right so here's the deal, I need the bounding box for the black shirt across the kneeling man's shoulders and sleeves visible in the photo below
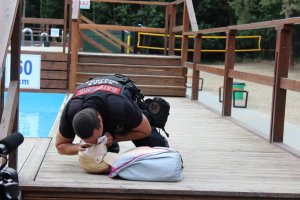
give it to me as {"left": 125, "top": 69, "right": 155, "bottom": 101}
{"left": 59, "top": 91, "right": 142, "bottom": 138}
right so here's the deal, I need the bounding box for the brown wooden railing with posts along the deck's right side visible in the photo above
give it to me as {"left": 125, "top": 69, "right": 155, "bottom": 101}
{"left": 182, "top": 4, "right": 300, "bottom": 142}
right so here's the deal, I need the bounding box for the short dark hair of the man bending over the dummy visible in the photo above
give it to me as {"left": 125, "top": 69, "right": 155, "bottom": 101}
{"left": 72, "top": 108, "right": 100, "bottom": 139}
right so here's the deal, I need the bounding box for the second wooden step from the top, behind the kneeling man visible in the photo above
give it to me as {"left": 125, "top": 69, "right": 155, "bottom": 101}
{"left": 77, "top": 63, "right": 183, "bottom": 76}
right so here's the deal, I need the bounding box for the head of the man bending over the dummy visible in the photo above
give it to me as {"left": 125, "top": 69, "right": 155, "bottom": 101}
{"left": 72, "top": 108, "right": 103, "bottom": 143}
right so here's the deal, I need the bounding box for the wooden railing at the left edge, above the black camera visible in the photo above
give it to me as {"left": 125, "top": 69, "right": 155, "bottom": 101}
{"left": 0, "top": 0, "right": 22, "bottom": 169}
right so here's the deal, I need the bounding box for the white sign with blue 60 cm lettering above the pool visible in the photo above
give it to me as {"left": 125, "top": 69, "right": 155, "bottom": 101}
{"left": 5, "top": 54, "right": 41, "bottom": 89}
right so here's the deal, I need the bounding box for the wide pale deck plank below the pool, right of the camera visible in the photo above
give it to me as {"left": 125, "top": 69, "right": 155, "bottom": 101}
{"left": 19, "top": 138, "right": 51, "bottom": 181}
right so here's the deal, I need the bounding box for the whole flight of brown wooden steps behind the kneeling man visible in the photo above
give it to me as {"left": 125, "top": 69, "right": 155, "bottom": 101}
{"left": 76, "top": 53, "right": 186, "bottom": 97}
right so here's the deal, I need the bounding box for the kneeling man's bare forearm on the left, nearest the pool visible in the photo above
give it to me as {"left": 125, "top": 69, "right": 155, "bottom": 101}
{"left": 55, "top": 132, "right": 84, "bottom": 155}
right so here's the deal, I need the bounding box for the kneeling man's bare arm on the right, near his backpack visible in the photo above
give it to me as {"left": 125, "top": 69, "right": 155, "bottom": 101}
{"left": 114, "top": 114, "right": 152, "bottom": 142}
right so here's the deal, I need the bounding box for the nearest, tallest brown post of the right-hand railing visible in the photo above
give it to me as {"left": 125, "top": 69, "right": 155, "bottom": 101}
{"left": 270, "top": 25, "right": 293, "bottom": 142}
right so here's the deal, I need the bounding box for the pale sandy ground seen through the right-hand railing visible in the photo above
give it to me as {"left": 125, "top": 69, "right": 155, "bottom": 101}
{"left": 188, "top": 61, "right": 300, "bottom": 126}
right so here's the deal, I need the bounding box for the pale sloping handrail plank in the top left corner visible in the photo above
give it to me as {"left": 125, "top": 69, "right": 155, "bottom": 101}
{"left": 0, "top": 0, "right": 19, "bottom": 71}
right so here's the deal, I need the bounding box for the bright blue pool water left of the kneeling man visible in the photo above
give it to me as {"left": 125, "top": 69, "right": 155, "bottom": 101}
{"left": 5, "top": 92, "right": 66, "bottom": 137}
